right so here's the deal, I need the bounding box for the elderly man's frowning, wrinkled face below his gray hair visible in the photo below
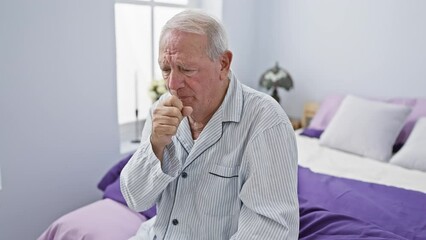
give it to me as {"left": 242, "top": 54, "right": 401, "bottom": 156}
{"left": 158, "top": 31, "right": 224, "bottom": 114}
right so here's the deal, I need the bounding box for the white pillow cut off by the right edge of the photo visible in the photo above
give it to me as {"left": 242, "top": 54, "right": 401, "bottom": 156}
{"left": 390, "top": 118, "right": 426, "bottom": 172}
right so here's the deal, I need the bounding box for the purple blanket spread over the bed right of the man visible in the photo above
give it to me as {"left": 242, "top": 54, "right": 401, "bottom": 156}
{"left": 298, "top": 167, "right": 426, "bottom": 239}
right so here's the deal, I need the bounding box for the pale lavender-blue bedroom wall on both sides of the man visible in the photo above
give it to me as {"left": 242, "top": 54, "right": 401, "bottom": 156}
{"left": 0, "top": 0, "right": 426, "bottom": 239}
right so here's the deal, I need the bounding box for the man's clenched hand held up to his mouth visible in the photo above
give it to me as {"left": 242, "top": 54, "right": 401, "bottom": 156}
{"left": 151, "top": 95, "right": 192, "bottom": 161}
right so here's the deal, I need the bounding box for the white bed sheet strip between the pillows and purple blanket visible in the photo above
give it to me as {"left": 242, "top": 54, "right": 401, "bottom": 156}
{"left": 296, "top": 130, "right": 426, "bottom": 193}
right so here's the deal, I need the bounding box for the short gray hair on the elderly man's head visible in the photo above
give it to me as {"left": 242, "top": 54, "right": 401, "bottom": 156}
{"left": 160, "top": 10, "right": 228, "bottom": 61}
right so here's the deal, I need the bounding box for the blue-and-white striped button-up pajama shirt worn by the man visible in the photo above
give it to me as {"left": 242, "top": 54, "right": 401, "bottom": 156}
{"left": 121, "top": 72, "right": 299, "bottom": 240}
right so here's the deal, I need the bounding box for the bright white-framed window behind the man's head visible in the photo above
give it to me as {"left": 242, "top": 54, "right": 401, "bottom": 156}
{"left": 115, "top": 0, "right": 196, "bottom": 153}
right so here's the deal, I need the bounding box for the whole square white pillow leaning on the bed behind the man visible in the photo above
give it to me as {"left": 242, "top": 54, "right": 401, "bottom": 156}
{"left": 319, "top": 95, "right": 411, "bottom": 162}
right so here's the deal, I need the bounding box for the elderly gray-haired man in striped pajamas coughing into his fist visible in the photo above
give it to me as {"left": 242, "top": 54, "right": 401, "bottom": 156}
{"left": 121, "top": 11, "right": 299, "bottom": 240}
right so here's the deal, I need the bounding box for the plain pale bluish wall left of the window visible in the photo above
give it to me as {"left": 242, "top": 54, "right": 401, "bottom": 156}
{"left": 0, "top": 0, "right": 120, "bottom": 240}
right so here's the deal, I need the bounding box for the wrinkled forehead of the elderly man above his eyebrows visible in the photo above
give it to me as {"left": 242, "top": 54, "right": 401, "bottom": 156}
{"left": 159, "top": 31, "right": 207, "bottom": 60}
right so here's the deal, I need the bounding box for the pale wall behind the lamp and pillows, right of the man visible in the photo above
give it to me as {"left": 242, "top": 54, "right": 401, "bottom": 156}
{"left": 223, "top": 0, "right": 426, "bottom": 116}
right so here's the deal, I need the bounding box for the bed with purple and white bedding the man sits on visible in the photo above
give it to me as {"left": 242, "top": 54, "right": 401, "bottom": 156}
{"left": 38, "top": 95, "right": 426, "bottom": 240}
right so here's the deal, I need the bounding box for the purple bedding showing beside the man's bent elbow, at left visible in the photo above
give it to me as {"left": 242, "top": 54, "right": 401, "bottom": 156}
{"left": 98, "top": 154, "right": 157, "bottom": 219}
